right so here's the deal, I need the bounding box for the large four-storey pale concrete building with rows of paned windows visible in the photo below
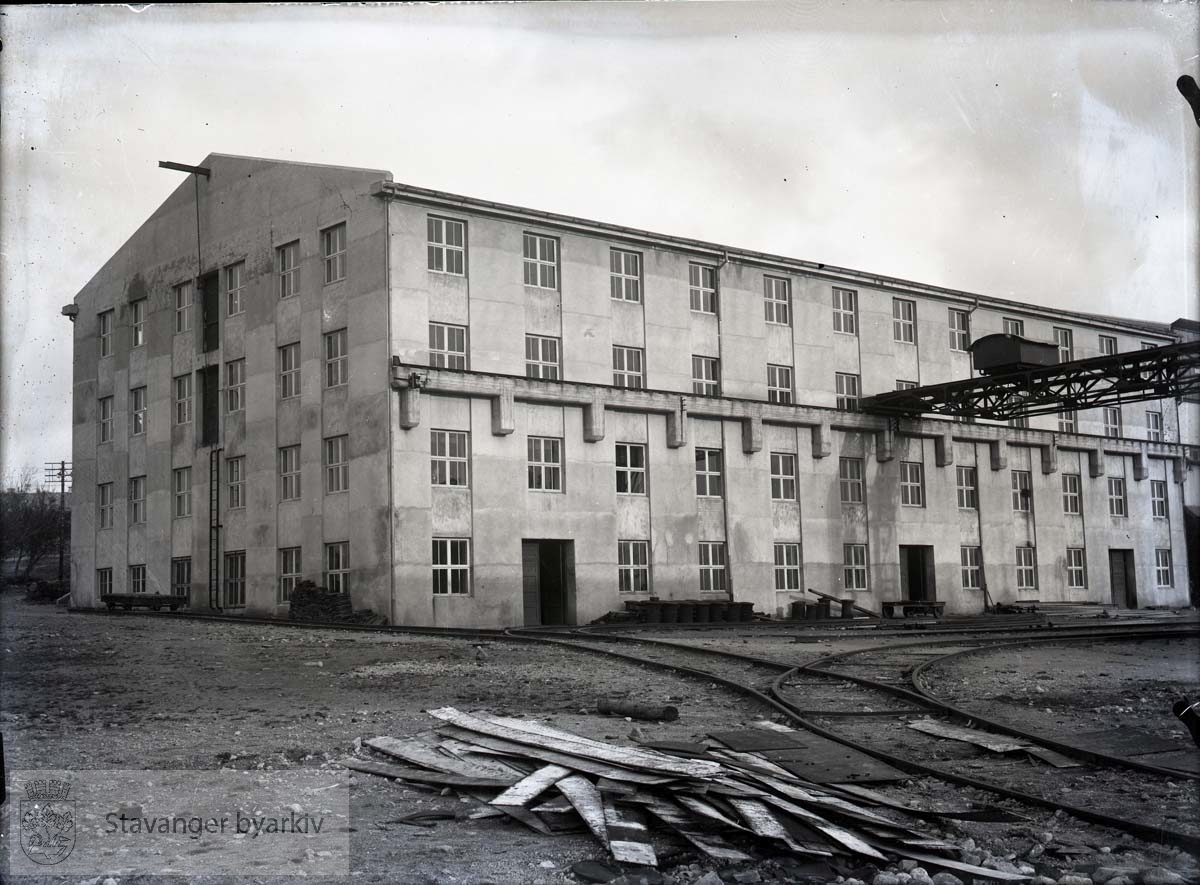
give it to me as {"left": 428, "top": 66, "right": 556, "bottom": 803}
{"left": 72, "top": 155, "right": 1188, "bottom": 626}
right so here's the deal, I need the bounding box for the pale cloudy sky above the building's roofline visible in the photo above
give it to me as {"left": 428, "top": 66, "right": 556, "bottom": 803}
{"left": 0, "top": 0, "right": 1200, "bottom": 477}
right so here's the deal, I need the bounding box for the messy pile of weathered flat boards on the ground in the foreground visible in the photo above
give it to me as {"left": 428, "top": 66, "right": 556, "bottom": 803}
{"left": 342, "top": 706, "right": 1026, "bottom": 881}
